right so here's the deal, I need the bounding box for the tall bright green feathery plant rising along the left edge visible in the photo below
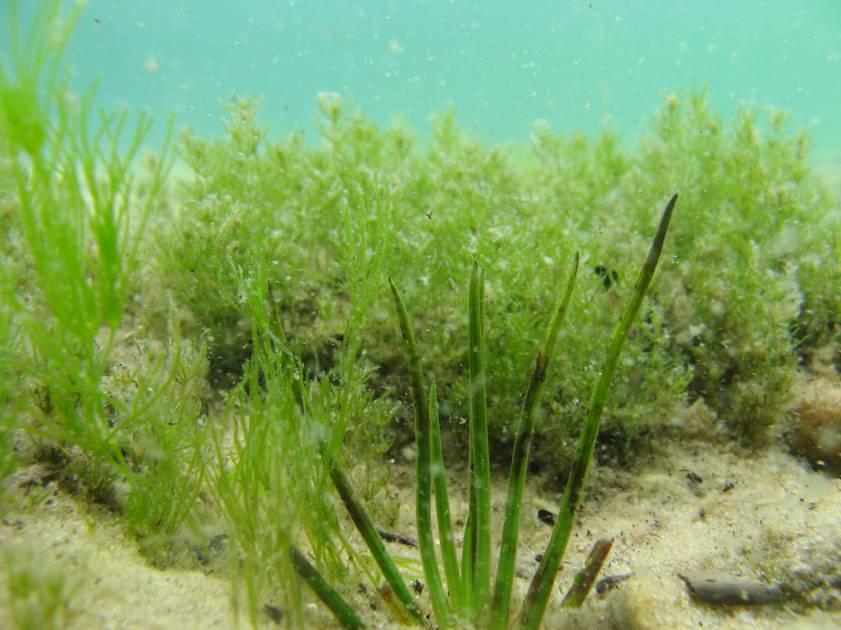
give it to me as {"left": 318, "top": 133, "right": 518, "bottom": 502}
{"left": 0, "top": 0, "right": 172, "bottom": 462}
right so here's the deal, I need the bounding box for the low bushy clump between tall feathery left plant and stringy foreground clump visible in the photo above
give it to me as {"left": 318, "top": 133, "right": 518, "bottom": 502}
{"left": 112, "top": 334, "right": 212, "bottom": 565}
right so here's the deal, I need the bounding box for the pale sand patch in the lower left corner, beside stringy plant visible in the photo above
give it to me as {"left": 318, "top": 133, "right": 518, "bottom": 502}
{"left": 0, "top": 492, "right": 235, "bottom": 629}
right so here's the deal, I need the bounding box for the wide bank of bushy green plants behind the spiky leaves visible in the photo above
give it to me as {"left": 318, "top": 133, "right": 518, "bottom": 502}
{"left": 161, "top": 84, "right": 841, "bottom": 474}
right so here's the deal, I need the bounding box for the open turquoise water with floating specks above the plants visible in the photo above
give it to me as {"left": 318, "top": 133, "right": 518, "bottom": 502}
{"left": 0, "top": 0, "right": 841, "bottom": 162}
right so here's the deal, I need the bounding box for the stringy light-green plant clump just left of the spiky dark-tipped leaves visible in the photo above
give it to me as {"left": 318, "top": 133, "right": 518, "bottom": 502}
{"left": 209, "top": 283, "right": 343, "bottom": 626}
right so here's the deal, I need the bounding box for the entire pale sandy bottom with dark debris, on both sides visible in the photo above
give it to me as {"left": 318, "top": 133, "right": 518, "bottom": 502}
{"left": 0, "top": 418, "right": 841, "bottom": 629}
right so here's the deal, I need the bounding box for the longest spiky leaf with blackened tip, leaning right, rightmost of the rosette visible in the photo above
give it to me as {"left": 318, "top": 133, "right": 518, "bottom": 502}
{"left": 520, "top": 194, "right": 677, "bottom": 630}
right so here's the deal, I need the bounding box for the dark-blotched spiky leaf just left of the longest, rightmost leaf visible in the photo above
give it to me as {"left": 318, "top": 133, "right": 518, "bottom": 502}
{"left": 490, "top": 252, "right": 579, "bottom": 630}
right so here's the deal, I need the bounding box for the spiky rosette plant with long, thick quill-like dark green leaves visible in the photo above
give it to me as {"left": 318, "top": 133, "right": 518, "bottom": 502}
{"left": 297, "top": 195, "right": 677, "bottom": 629}
